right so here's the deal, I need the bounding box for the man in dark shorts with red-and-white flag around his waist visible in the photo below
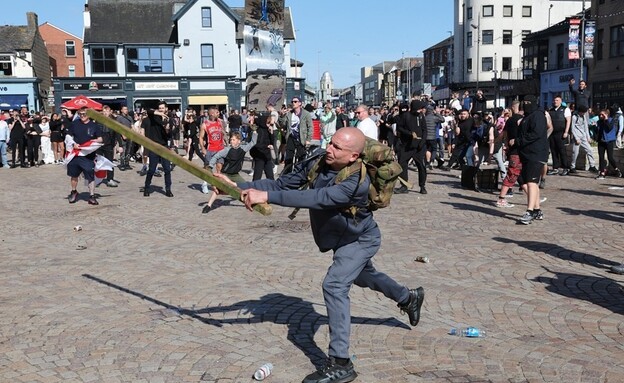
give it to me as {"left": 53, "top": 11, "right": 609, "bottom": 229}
{"left": 67, "top": 108, "right": 103, "bottom": 205}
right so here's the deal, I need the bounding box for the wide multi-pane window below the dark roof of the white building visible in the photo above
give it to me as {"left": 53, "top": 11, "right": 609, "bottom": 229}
{"left": 126, "top": 47, "right": 173, "bottom": 73}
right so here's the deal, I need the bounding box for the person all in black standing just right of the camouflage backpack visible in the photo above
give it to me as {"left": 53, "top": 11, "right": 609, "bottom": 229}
{"left": 394, "top": 100, "right": 427, "bottom": 194}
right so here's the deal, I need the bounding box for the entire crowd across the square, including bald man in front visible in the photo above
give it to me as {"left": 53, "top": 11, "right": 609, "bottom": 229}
{"left": 0, "top": 82, "right": 624, "bottom": 383}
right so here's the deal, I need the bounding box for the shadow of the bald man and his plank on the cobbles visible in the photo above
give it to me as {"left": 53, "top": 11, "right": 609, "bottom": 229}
{"left": 82, "top": 274, "right": 411, "bottom": 368}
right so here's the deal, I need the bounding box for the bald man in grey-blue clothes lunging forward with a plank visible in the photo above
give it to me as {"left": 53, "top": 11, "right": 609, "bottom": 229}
{"left": 216, "top": 127, "right": 424, "bottom": 383}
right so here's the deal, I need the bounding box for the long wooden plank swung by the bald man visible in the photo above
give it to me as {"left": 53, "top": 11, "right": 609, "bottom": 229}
{"left": 87, "top": 109, "right": 273, "bottom": 215}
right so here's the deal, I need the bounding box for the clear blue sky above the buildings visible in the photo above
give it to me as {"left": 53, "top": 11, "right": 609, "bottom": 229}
{"left": 0, "top": 0, "right": 454, "bottom": 88}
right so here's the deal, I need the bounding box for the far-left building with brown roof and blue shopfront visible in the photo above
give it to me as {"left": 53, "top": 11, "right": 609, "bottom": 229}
{"left": 0, "top": 12, "right": 51, "bottom": 111}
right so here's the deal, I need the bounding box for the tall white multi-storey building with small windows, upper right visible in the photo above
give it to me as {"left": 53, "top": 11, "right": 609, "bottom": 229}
{"left": 453, "top": 0, "right": 584, "bottom": 88}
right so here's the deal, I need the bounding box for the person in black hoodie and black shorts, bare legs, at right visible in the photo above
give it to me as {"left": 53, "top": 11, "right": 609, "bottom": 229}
{"left": 509, "top": 95, "right": 549, "bottom": 225}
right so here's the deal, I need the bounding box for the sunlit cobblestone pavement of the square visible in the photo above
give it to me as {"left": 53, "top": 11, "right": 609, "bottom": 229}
{"left": 0, "top": 158, "right": 624, "bottom": 383}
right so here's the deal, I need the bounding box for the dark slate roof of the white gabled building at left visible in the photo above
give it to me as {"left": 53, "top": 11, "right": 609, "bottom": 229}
{"left": 84, "top": 0, "right": 180, "bottom": 44}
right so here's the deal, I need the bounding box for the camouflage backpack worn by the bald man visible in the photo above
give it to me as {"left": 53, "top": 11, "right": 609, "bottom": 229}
{"left": 308, "top": 137, "right": 402, "bottom": 216}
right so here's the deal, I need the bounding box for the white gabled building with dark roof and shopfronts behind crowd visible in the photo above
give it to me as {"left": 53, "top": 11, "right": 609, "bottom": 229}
{"left": 54, "top": 0, "right": 305, "bottom": 110}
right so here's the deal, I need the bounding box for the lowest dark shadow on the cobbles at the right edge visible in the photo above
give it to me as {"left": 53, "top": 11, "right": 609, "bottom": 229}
{"left": 532, "top": 268, "right": 624, "bottom": 315}
